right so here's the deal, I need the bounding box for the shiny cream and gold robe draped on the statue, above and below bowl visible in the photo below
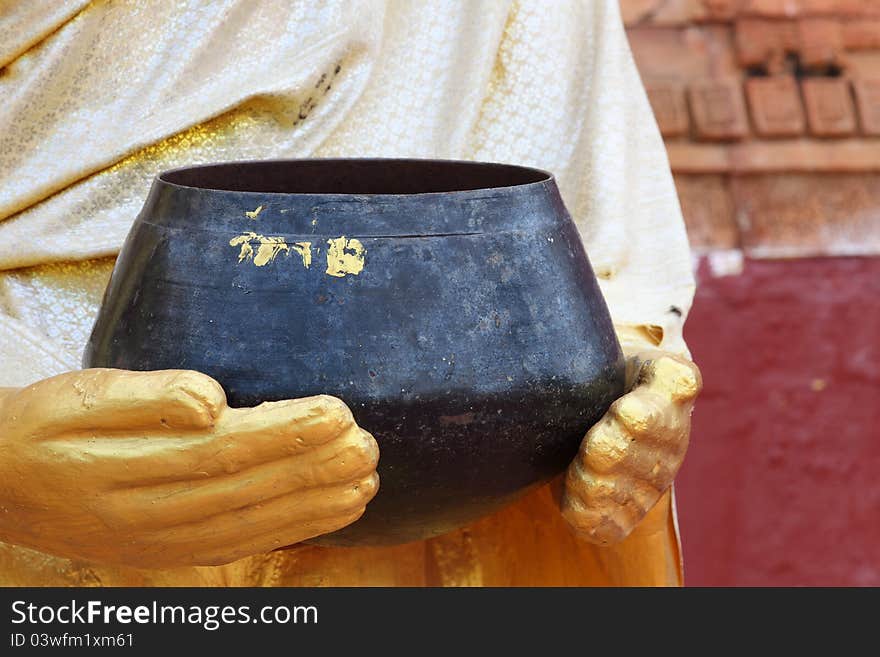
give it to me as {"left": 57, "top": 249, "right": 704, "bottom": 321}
{"left": 0, "top": 0, "right": 694, "bottom": 585}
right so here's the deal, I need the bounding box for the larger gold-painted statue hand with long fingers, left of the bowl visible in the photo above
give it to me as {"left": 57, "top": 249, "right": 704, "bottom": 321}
{"left": 0, "top": 369, "right": 379, "bottom": 568}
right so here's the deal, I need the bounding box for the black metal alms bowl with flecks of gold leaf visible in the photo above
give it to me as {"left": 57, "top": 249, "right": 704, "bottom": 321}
{"left": 84, "top": 160, "right": 623, "bottom": 545}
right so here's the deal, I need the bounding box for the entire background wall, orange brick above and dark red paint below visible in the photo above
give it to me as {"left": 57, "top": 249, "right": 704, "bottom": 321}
{"left": 621, "top": 0, "right": 880, "bottom": 585}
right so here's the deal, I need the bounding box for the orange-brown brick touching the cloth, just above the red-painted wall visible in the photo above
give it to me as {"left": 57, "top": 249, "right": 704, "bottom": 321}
{"left": 675, "top": 174, "right": 739, "bottom": 250}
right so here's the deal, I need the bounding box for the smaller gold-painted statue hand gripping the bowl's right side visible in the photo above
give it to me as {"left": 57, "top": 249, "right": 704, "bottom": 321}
{"left": 562, "top": 351, "right": 702, "bottom": 545}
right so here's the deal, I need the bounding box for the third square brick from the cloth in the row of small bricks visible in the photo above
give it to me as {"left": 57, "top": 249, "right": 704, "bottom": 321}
{"left": 746, "top": 75, "right": 806, "bottom": 137}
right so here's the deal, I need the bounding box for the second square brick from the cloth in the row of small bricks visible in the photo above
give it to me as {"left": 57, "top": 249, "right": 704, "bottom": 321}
{"left": 688, "top": 78, "right": 749, "bottom": 141}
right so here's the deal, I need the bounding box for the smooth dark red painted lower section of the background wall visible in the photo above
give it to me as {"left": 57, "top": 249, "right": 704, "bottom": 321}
{"left": 677, "top": 258, "right": 880, "bottom": 586}
